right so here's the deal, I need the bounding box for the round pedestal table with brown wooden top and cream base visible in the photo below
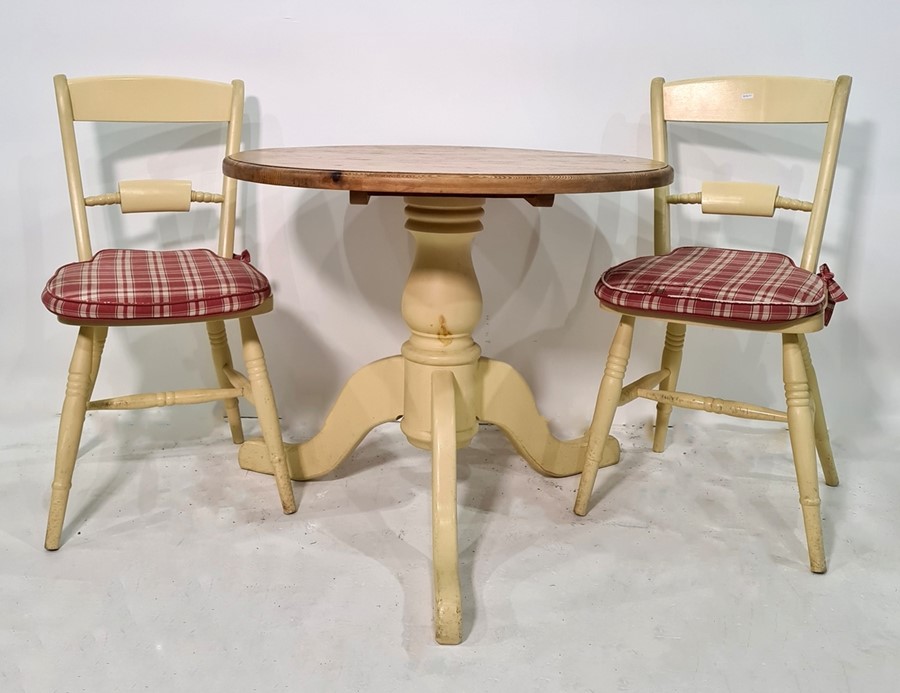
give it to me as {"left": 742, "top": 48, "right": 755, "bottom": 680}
{"left": 223, "top": 145, "right": 673, "bottom": 644}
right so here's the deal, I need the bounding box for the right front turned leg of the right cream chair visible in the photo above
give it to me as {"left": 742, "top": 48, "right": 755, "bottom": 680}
{"left": 782, "top": 334, "right": 826, "bottom": 573}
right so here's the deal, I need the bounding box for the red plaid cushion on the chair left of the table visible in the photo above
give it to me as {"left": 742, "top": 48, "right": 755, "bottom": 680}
{"left": 41, "top": 249, "right": 272, "bottom": 321}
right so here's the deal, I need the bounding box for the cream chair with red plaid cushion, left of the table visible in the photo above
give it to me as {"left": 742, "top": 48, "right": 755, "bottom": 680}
{"left": 42, "top": 75, "right": 296, "bottom": 550}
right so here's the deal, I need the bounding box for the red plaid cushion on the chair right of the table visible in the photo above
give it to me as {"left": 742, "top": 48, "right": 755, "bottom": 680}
{"left": 595, "top": 247, "right": 847, "bottom": 324}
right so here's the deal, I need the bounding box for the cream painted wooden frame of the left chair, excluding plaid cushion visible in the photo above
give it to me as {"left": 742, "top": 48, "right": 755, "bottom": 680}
{"left": 45, "top": 75, "right": 296, "bottom": 550}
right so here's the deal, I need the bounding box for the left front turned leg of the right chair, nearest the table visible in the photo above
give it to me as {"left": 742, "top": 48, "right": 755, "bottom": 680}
{"left": 575, "top": 315, "right": 634, "bottom": 515}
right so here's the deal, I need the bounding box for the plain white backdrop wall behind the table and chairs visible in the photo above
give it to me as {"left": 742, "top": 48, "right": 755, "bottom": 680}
{"left": 0, "top": 0, "right": 900, "bottom": 444}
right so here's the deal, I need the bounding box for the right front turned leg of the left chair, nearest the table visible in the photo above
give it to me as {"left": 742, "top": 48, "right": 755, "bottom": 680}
{"left": 240, "top": 318, "right": 297, "bottom": 515}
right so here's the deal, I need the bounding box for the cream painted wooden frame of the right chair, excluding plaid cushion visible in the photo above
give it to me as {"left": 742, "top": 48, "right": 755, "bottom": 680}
{"left": 575, "top": 76, "right": 850, "bottom": 572}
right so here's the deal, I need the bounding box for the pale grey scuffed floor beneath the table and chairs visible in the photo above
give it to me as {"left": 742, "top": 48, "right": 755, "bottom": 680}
{"left": 0, "top": 407, "right": 900, "bottom": 693}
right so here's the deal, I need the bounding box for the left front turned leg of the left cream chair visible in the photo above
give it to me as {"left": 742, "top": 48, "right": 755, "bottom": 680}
{"left": 44, "top": 327, "right": 94, "bottom": 551}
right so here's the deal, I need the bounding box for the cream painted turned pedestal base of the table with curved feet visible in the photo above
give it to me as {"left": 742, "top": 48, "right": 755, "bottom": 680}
{"left": 240, "top": 197, "right": 619, "bottom": 644}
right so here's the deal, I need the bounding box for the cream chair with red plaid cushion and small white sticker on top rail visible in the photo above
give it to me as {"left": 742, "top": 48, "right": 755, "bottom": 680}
{"left": 575, "top": 76, "right": 850, "bottom": 573}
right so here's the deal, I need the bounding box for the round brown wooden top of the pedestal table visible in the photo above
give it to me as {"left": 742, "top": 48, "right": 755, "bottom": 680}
{"left": 222, "top": 145, "right": 673, "bottom": 197}
